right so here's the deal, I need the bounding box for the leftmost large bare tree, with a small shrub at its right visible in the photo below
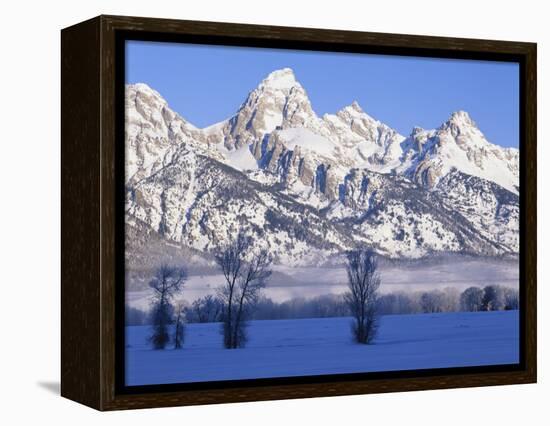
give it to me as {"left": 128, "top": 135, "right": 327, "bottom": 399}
{"left": 149, "top": 264, "right": 187, "bottom": 349}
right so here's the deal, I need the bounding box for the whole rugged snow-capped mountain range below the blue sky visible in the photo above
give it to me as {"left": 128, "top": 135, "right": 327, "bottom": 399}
{"left": 126, "top": 68, "right": 519, "bottom": 264}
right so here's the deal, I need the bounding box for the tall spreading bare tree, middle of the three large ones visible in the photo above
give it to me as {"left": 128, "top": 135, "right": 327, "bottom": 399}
{"left": 215, "top": 232, "right": 271, "bottom": 349}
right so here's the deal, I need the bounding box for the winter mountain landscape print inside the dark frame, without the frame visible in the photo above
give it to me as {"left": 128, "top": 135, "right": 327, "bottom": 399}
{"left": 124, "top": 41, "right": 521, "bottom": 386}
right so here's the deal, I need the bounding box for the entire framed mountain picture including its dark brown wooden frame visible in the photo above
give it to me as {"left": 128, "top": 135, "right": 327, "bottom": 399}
{"left": 61, "top": 16, "right": 536, "bottom": 410}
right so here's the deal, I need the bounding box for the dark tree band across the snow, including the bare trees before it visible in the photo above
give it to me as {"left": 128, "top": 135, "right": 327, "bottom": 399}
{"left": 126, "top": 232, "right": 519, "bottom": 349}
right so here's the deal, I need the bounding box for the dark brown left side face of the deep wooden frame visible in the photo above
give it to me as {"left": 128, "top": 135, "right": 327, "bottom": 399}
{"left": 61, "top": 18, "right": 101, "bottom": 409}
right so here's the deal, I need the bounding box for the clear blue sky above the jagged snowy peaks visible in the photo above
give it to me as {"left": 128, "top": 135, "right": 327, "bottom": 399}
{"left": 126, "top": 41, "right": 519, "bottom": 147}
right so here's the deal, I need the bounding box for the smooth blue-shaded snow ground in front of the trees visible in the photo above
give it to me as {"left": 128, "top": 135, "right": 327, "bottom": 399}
{"left": 126, "top": 311, "right": 519, "bottom": 386}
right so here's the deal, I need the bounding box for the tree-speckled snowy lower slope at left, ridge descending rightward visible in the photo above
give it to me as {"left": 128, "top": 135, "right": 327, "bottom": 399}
{"left": 126, "top": 145, "right": 353, "bottom": 265}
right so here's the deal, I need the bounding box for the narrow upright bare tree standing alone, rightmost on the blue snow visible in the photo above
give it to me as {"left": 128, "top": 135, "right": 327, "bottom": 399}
{"left": 345, "top": 249, "right": 380, "bottom": 344}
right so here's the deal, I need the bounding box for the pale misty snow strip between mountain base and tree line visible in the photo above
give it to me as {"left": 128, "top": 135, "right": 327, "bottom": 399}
{"left": 126, "top": 258, "right": 519, "bottom": 310}
